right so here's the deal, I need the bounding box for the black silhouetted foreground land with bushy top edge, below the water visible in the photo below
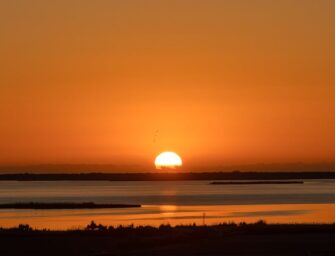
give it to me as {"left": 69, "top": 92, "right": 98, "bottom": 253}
{"left": 0, "top": 222, "right": 335, "bottom": 256}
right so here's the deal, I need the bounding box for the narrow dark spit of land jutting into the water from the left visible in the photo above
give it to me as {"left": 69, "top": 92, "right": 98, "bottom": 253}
{"left": 0, "top": 202, "right": 141, "bottom": 210}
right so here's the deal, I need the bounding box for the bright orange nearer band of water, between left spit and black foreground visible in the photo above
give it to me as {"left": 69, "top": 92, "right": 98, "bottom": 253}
{"left": 0, "top": 204, "right": 335, "bottom": 230}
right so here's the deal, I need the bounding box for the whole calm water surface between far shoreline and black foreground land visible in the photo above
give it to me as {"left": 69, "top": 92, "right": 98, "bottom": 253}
{"left": 0, "top": 180, "right": 335, "bottom": 229}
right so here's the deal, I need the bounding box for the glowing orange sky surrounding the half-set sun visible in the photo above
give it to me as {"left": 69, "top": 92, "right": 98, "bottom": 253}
{"left": 0, "top": 0, "right": 335, "bottom": 169}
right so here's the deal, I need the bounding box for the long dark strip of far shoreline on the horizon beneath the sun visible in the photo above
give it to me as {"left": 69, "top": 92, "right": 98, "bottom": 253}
{"left": 0, "top": 171, "right": 335, "bottom": 181}
